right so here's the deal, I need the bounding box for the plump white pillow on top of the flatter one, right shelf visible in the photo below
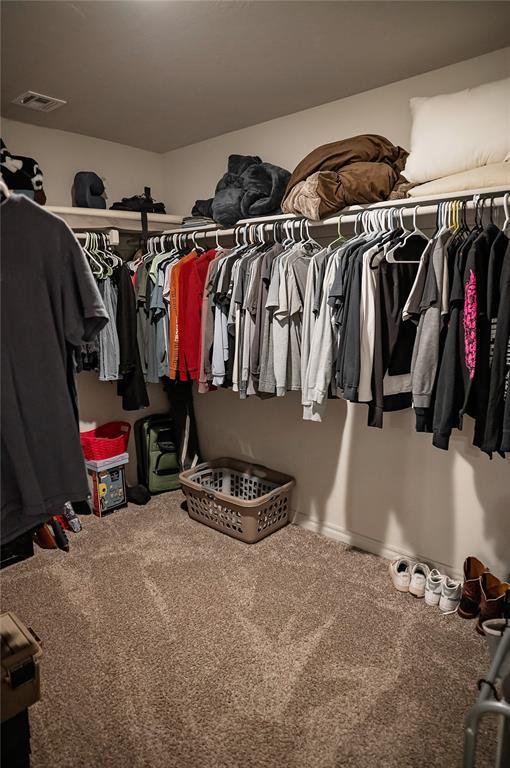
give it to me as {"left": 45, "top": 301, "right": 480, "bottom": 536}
{"left": 403, "top": 78, "right": 510, "bottom": 183}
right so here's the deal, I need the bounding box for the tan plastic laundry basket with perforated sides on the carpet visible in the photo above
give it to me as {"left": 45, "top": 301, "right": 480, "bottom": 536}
{"left": 180, "top": 459, "right": 295, "bottom": 544}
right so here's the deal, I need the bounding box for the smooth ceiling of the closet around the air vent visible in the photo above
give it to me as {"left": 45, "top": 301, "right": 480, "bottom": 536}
{"left": 1, "top": 0, "right": 510, "bottom": 152}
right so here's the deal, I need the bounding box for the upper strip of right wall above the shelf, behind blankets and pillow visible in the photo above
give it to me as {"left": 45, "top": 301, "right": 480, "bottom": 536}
{"left": 164, "top": 41, "right": 510, "bottom": 213}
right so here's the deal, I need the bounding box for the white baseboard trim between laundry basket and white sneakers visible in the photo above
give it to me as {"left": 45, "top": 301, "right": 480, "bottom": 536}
{"left": 293, "top": 512, "right": 464, "bottom": 580}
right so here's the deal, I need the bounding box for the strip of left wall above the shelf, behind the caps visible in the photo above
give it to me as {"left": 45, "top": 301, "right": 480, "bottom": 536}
{"left": 2, "top": 119, "right": 165, "bottom": 207}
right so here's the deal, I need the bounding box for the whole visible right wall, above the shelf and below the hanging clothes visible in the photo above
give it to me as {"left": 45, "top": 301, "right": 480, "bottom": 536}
{"left": 164, "top": 48, "right": 510, "bottom": 576}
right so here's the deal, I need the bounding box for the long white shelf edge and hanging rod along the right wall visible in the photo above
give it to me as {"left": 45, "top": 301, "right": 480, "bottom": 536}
{"left": 163, "top": 187, "right": 510, "bottom": 237}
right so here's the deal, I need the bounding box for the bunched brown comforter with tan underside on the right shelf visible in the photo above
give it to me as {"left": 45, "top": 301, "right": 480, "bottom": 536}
{"left": 282, "top": 134, "right": 409, "bottom": 220}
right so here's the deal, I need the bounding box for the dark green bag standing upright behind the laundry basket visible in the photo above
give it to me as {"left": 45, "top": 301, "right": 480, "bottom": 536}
{"left": 135, "top": 414, "right": 181, "bottom": 494}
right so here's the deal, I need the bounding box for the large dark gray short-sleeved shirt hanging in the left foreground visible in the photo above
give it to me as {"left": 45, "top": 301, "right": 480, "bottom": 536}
{"left": 1, "top": 195, "right": 108, "bottom": 543}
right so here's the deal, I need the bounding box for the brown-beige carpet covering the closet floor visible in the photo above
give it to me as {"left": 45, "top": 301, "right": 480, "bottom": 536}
{"left": 2, "top": 494, "right": 491, "bottom": 768}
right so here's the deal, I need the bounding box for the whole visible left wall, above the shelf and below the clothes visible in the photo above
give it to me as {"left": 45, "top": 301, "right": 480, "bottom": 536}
{"left": 2, "top": 120, "right": 168, "bottom": 482}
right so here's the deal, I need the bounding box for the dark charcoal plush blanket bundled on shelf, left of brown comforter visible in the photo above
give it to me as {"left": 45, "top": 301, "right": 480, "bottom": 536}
{"left": 191, "top": 155, "right": 290, "bottom": 227}
